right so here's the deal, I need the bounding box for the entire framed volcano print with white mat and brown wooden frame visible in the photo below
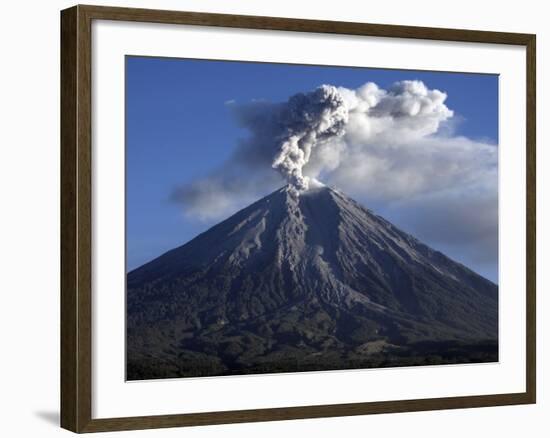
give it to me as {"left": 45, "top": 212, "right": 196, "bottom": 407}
{"left": 61, "top": 6, "right": 536, "bottom": 432}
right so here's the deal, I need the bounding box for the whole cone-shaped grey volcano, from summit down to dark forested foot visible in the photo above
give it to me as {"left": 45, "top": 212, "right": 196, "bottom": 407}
{"left": 127, "top": 186, "right": 498, "bottom": 380}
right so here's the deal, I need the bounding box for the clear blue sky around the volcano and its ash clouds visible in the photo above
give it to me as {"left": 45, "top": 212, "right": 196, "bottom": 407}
{"left": 126, "top": 57, "right": 498, "bottom": 281}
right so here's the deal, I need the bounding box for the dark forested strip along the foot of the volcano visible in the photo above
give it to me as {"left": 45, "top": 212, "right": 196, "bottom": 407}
{"left": 126, "top": 341, "right": 499, "bottom": 380}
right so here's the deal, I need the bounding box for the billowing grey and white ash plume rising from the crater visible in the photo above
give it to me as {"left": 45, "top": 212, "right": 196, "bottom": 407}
{"left": 260, "top": 81, "right": 453, "bottom": 194}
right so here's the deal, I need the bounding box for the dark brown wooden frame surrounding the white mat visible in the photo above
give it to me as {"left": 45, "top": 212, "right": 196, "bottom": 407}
{"left": 61, "top": 5, "right": 536, "bottom": 433}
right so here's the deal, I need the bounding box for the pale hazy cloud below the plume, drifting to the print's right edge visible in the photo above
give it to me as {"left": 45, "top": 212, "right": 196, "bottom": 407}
{"left": 314, "top": 137, "right": 498, "bottom": 202}
